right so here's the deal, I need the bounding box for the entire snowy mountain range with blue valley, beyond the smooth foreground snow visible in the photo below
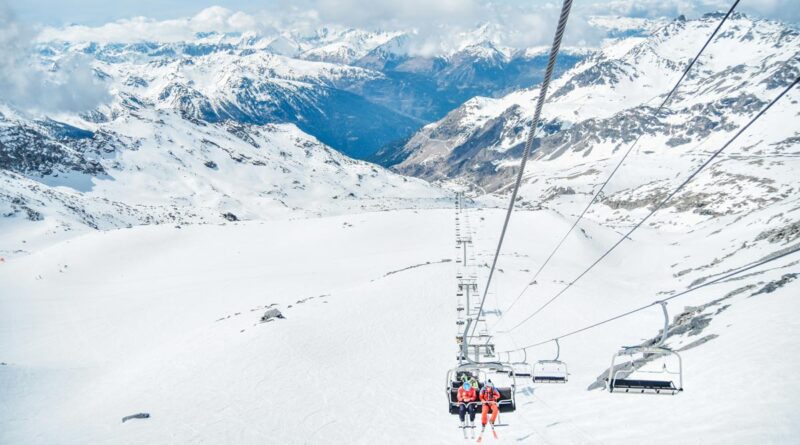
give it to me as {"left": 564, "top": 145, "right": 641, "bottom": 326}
{"left": 0, "top": 14, "right": 800, "bottom": 250}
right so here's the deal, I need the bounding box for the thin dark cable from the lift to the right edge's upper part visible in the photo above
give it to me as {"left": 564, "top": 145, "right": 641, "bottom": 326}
{"left": 502, "top": 76, "right": 800, "bottom": 332}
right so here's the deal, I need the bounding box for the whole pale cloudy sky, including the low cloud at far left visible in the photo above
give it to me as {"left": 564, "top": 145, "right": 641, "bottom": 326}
{"left": 0, "top": 0, "right": 800, "bottom": 110}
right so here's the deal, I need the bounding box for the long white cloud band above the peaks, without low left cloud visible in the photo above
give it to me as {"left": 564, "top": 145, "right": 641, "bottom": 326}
{"left": 28, "top": 0, "right": 800, "bottom": 54}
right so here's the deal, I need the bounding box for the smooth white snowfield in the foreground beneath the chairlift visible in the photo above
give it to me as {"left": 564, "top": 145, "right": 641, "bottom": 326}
{"left": 0, "top": 199, "right": 800, "bottom": 444}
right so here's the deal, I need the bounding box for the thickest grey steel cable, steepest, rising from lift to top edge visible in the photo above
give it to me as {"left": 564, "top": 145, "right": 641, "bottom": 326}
{"left": 472, "top": 0, "right": 572, "bottom": 334}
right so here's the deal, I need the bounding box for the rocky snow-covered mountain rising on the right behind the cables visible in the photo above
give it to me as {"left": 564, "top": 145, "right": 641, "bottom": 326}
{"left": 396, "top": 14, "right": 800, "bottom": 191}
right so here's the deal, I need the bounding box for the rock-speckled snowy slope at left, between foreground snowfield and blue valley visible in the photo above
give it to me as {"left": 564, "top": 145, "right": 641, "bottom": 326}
{"left": 0, "top": 98, "right": 446, "bottom": 255}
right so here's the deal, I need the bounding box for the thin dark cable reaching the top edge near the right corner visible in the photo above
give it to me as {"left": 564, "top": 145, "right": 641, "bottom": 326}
{"left": 492, "top": 0, "right": 741, "bottom": 326}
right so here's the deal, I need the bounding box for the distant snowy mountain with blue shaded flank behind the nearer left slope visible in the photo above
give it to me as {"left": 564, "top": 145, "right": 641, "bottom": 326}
{"left": 42, "top": 37, "right": 421, "bottom": 158}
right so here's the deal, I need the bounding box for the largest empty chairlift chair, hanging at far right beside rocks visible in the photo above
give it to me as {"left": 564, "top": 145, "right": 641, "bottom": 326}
{"left": 606, "top": 301, "right": 683, "bottom": 395}
